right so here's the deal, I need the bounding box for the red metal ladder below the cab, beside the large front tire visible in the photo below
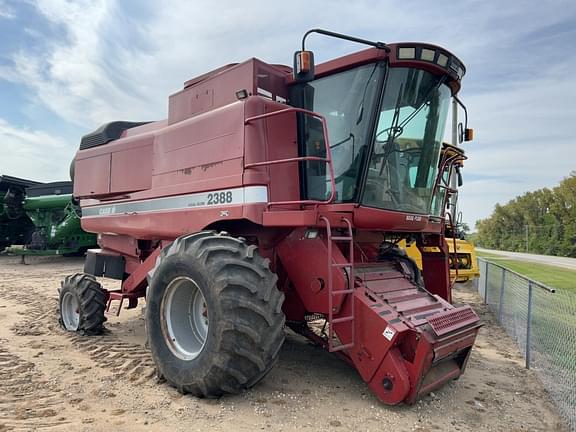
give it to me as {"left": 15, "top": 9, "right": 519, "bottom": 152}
{"left": 320, "top": 216, "right": 355, "bottom": 352}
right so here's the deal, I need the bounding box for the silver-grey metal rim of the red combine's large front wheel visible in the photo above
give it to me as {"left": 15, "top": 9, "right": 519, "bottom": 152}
{"left": 161, "top": 276, "right": 209, "bottom": 360}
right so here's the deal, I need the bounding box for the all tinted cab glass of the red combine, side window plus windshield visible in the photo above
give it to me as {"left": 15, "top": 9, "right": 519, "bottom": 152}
{"left": 293, "top": 63, "right": 451, "bottom": 214}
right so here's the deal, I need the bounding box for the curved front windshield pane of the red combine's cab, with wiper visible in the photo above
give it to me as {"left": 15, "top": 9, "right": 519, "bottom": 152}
{"left": 362, "top": 68, "right": 451, "bottom": 214}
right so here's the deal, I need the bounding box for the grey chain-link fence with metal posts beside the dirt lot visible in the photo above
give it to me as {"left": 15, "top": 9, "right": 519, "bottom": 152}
{"left": 478, "top": 258, "right": 576, "bottom": 431}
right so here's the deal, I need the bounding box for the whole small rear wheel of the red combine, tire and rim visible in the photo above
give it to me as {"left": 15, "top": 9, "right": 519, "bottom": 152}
{"left": 58, "top": 273, "right": 108, "bottom": 335}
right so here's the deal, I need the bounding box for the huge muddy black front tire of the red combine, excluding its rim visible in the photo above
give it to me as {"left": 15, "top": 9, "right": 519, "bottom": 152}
{"left": 146, "top": 231, "right": 285, "bottom": 398}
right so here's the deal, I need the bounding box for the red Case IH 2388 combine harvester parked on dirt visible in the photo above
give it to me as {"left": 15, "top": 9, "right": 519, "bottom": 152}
{"left": 60, "top": 29, "right": 480, "bottom": 405}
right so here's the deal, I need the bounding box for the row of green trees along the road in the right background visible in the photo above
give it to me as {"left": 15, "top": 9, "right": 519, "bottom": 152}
{"left": 475, "top": 171, "right": 576, "bottom": 257}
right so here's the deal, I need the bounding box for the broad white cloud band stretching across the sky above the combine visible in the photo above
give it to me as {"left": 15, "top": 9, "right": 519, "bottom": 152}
{"left": 15, "top": 0, "right": 568, "bottom": 126}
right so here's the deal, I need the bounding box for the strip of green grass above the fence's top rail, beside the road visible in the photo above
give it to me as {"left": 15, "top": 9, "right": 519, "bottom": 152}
{"left": 478, "top": 253, "right": 576, "bottom": 291}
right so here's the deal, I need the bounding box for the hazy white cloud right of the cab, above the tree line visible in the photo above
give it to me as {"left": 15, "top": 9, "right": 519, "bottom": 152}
{"left": 461, "top": 63, "right": 576, "bottom": 226}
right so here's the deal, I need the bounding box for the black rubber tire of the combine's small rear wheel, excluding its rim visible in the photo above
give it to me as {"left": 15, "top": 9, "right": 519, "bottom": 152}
{"left": 58, "top": 273, "right": 108, "bottom": 336}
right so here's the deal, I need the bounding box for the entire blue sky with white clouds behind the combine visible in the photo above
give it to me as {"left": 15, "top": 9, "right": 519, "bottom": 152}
{"left": 0, "top": 0, "right": 576, "bottom": 227}
